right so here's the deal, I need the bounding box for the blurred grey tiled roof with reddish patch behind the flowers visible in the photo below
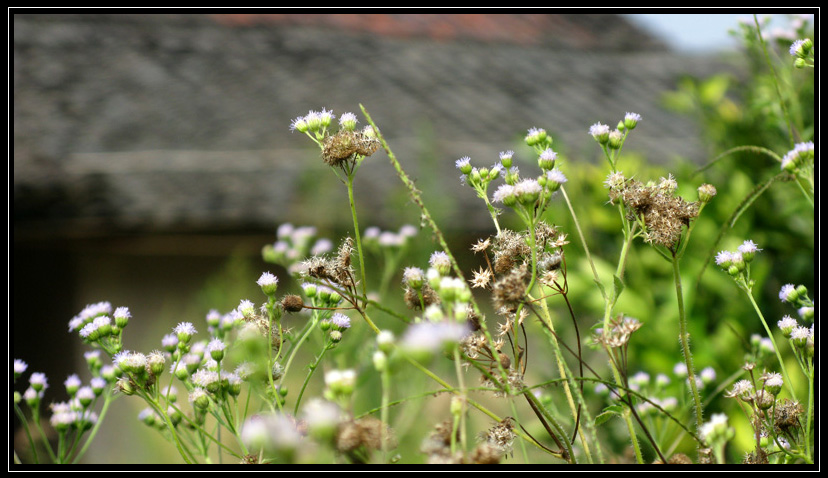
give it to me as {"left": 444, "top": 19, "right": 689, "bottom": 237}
{"left": 13, "top": 13, "right": 736, "bottom": 235}
